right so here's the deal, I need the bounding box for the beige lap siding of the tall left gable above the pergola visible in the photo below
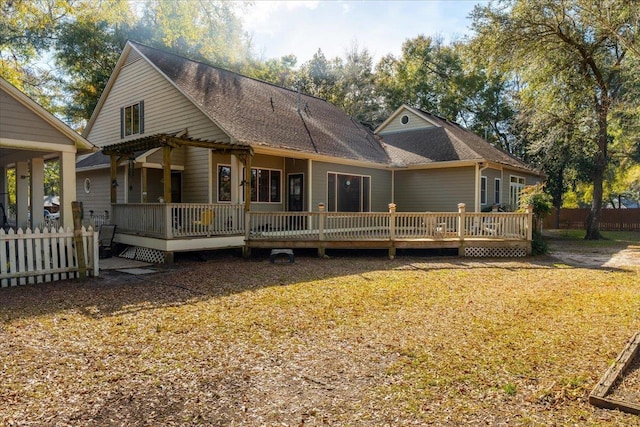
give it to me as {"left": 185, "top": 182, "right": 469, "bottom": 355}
{"left": 88, "top": 53, "right": 229, "bottom": 146}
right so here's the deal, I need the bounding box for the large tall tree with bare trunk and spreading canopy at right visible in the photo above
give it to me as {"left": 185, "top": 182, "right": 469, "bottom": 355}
{"left": 472, "top": 0, "right": 640, "bottom": 239}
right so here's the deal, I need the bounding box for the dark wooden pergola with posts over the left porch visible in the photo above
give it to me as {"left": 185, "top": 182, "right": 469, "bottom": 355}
{"left": 102, "top": 130, "right": 253, "bottom": 211}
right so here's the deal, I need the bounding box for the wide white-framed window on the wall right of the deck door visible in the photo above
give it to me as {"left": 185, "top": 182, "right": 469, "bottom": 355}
{"left": 327, "top": 172, "right": 371, "bottom": 212}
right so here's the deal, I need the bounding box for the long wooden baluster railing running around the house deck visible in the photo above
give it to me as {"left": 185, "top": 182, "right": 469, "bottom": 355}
{"left": 111, "top": 203, "right": 532, "bottom": 241}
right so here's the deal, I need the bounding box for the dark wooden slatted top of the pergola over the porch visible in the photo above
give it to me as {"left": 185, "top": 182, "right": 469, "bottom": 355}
{"left": 102, "top": 132, "right": 253, "bottom": 156}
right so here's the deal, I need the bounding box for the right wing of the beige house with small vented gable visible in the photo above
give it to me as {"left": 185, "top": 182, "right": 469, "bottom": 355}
{"left": 375, "top": 105, "right": 542, "bottom": 212}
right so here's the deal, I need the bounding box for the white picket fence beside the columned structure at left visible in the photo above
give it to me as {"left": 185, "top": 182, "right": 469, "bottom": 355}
{"left": 0, "top": 227, "right": 99, "bottom": 288}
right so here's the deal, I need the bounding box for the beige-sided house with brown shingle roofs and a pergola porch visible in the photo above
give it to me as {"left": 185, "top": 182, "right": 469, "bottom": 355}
{"left": 76, "top": 42, "right": 540, "bottom": 260}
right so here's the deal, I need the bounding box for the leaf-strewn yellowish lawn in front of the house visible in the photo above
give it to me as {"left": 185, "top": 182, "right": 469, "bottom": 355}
{"left": 0, "top": 233, "right": 640, "bottom": 426}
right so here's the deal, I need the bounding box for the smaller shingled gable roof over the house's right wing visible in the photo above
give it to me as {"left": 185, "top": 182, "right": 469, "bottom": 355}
{"left": 376, "top": 105, "right": 534, "bottom": 172}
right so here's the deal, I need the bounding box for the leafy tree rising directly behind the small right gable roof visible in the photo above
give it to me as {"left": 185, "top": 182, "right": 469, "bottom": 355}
{"left": 376, "top": 36, "right": 523, "bottom": 152}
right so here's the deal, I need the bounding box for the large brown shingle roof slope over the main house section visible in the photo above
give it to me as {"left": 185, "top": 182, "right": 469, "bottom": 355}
{"left": 129, "top": 42, "right": 389, "bottom": 164}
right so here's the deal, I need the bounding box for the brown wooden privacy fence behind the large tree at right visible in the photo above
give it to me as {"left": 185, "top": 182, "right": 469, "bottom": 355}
{"left": 543, "top": 208, "right": 640, "bottom": 231}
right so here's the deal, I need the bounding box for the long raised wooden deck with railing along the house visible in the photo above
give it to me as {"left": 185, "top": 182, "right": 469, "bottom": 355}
{"left": 112, "top": 203, "right": 532, "bottom": 257}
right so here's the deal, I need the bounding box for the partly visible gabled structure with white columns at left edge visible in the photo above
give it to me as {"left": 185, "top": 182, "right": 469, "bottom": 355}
{"left": 0, "top": 78, "right": 96, "bottom": 228}
